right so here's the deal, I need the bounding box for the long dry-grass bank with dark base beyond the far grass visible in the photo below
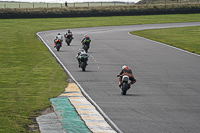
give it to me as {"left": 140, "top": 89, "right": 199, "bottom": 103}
{"left": 0, "top": 3, "right": 200, "bottom": 18}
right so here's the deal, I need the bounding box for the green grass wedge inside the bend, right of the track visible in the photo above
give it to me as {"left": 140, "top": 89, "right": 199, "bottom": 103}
{"left": 131, "top": 26, "right": 200, "bottom": 54}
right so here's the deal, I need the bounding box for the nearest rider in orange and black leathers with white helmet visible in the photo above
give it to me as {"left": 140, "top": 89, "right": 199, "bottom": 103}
{"left": 119, "top": 65, "right": 136, "bottom": 88}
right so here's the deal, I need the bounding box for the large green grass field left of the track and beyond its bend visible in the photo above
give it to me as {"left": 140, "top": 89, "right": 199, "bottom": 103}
{"left": 0, "top": 14, "right": 200, "bottom": 133}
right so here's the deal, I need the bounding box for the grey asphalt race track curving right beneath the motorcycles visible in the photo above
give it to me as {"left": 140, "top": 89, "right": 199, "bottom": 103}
{"left": 39, "top": 22, "right": 200, "bottom": 133}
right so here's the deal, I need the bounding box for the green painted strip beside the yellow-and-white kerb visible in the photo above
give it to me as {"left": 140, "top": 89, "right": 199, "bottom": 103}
{"left": 50, "top": 97, "right": 91, "bottom": 133}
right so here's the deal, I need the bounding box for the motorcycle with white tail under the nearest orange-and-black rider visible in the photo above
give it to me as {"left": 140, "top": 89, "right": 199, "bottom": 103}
{"left": 117, "top": 75, "right": 130, "bottom": 95}
